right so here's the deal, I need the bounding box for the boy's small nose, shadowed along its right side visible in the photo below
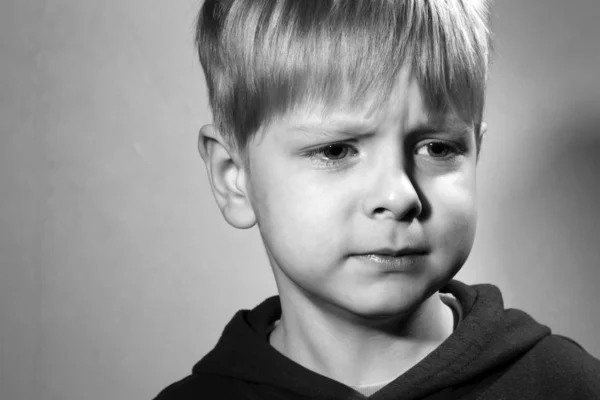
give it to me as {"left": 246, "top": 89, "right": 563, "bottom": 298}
{"left": 364, "top": 157, "right": 423, "bottom": 221}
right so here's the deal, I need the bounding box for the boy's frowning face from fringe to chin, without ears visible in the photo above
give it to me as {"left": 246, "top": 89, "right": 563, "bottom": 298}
{"left": 239, "top": 69, "right": 477, "bottom": 317}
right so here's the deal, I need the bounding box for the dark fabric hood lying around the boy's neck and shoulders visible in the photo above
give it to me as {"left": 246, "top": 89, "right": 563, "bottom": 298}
{"left": 193, "top": 280, "right": 551, "bottom": 399}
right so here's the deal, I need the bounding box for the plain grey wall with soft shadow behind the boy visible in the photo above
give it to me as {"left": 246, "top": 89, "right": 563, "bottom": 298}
{"left": 0, "top": 0, "right": 600, "bottom": 400}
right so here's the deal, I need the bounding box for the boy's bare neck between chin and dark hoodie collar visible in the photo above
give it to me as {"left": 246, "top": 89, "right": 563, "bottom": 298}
{"left": 269, "top": 292, "right": 453, "bottom": 386}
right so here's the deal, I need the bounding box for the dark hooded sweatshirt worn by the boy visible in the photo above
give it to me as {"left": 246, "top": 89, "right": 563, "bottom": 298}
{"left": 157, "top": 280, "right": 600, "bottom": 400}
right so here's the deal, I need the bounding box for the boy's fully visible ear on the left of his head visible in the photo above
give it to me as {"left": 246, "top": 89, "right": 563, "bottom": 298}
{"left": 198, "top": 125, "right": 256, "bottom": 229}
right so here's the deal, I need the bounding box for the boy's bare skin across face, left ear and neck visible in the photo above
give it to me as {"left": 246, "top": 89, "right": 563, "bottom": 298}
{"left": 199, "top": 69, "right": 483, "bottom": 385}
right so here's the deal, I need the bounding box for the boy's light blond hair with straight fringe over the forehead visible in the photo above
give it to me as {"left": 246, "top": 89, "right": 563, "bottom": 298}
{"left": 196, "top": 0, "right": 490, "bottom": 149}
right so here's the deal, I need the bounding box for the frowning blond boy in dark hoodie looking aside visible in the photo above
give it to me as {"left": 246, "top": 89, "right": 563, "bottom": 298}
{"left": 158, "top": 0, "right": 600, "bottom": 400}
